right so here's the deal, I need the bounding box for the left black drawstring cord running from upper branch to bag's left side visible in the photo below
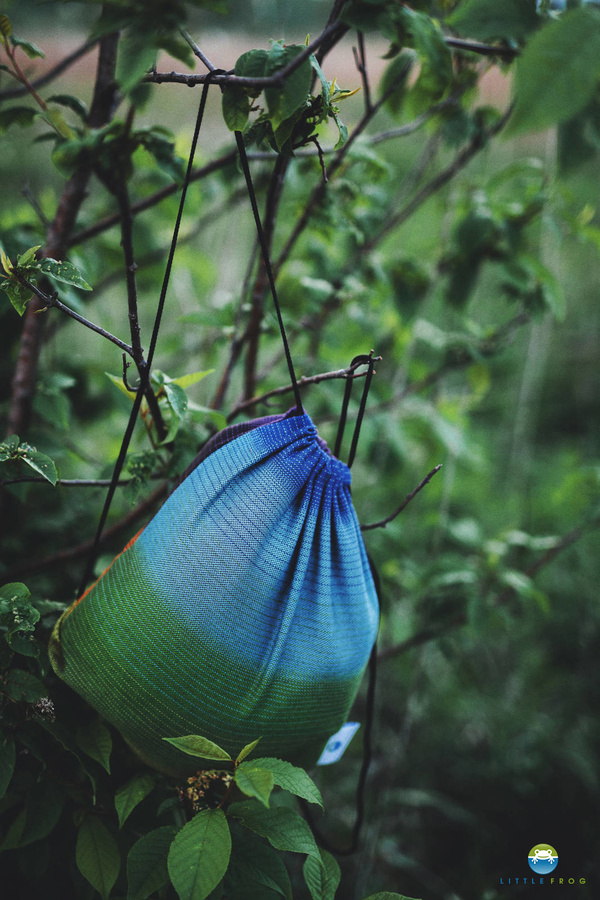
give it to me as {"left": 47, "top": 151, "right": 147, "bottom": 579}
{"left": 78, "top": 69, "right": 222, "bottom": 596}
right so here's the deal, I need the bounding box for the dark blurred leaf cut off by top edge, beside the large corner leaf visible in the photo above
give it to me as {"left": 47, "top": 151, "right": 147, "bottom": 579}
{"left": 447, "top": 0, "right": 541, "bottom": 41}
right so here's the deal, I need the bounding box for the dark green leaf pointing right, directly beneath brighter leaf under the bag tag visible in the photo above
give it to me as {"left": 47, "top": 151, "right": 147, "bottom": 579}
{"left": 227, "top": 800, "right": 321, "bottom": 864}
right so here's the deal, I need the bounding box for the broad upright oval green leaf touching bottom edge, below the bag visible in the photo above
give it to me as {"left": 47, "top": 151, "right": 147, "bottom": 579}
{"left": 167, "top": 809, "right": 231, "bottom": 900}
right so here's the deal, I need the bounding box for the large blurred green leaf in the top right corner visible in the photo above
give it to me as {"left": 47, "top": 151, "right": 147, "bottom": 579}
{"left": 506, "top": 5, "right": 600, "bottom": 135}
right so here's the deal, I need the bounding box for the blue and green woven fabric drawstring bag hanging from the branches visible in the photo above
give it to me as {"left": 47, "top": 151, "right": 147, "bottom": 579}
{"left": 51, "top": 415, "right": 379, "bottom": 775}
